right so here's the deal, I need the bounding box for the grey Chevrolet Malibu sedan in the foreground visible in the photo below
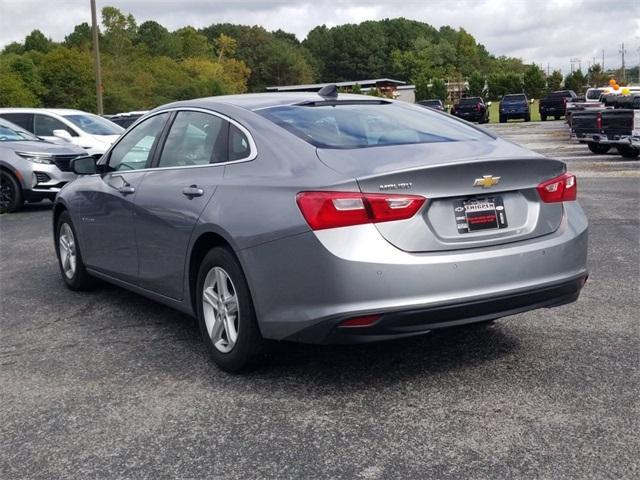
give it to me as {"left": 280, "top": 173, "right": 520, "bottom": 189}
{"left": 53, "top": 89, "right": 587, "bottom": 371}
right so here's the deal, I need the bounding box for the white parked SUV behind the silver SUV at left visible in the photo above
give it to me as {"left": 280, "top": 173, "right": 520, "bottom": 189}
{"left": 0, "top": 108, "right": 124, "bottom": 156}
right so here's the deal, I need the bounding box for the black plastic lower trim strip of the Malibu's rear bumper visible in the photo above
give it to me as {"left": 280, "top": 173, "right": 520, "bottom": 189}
{"left": 286, "top": 274, "right": 588, "bottom": 343}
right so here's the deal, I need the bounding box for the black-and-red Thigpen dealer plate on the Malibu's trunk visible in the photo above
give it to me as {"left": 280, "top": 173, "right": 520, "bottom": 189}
{"left": 453, "top": 195, "right": 509, "bottom": 234}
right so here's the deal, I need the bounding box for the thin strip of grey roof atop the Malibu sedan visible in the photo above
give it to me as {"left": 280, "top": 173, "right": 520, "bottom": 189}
{"left": 152, "top": 92, "right": 392, "bottom": 110}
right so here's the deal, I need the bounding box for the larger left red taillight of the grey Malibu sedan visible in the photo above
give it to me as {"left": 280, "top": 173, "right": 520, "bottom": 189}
{"left": 296, "top": 192, "right": 426, "bottom": 230}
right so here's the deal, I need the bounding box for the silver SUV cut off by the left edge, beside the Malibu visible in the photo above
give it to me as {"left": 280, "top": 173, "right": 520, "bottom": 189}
{"left": 0, "top": 119, "right": 86, "bottom": 213}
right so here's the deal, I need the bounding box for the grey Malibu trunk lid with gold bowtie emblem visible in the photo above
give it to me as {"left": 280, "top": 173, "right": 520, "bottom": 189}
{"left": 318, "top": 140, "right": 565, "bottom": 252}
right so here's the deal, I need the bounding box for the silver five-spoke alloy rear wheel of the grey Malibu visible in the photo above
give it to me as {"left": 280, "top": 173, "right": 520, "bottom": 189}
{"left": 202, "top": 267, "right": 240, "bottom": 353}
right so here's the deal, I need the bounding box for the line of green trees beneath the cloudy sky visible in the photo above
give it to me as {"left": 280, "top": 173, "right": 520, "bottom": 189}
{"left": 0, "top": 7, "right": 624, "bottom": 113}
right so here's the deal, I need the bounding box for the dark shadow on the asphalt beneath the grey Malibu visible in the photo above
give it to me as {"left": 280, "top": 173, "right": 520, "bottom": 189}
{"left": 89, "top": 284, "right": 520, "bottom": 388}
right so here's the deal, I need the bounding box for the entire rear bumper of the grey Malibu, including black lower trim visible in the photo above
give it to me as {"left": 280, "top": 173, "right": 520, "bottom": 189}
{"left": 239, "top": 202, "right": 588, "bottom": 343}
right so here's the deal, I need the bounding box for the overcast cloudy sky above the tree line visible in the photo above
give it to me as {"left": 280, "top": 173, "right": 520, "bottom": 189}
{"left": 0, "top": 0, "right": 640, "bottom": 72}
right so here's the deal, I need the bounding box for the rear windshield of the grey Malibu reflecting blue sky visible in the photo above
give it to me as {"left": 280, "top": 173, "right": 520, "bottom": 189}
{"left": 256, "top": 102, "right": 487, "bottom": 148}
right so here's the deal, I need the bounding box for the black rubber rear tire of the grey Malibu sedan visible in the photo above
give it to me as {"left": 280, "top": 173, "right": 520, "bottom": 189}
{"left": 196, "top": 247, "right": 267, "bottom": 373}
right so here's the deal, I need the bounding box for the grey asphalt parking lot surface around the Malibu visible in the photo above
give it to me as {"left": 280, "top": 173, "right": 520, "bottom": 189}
{"left": 0, "top": 122, "right": 640, "bottom": 479}
